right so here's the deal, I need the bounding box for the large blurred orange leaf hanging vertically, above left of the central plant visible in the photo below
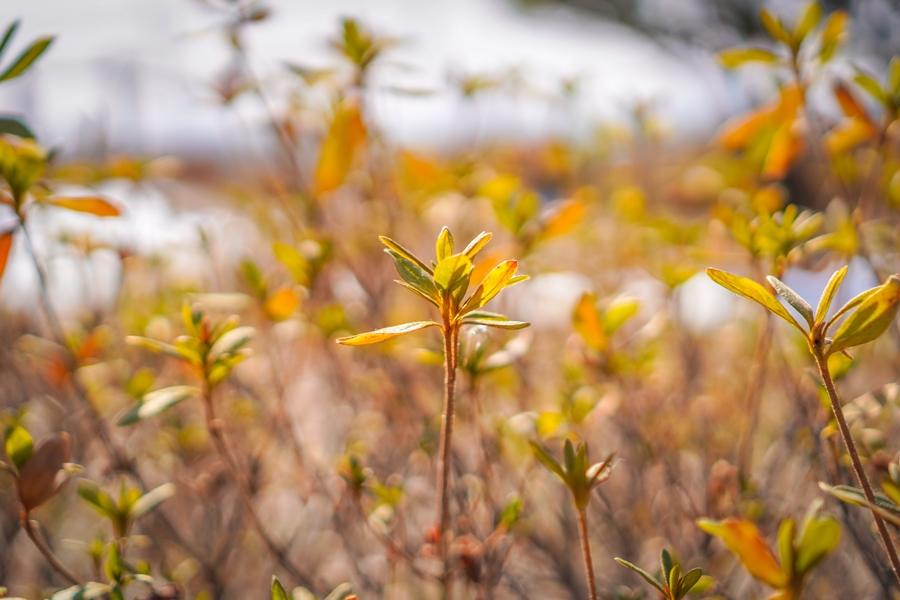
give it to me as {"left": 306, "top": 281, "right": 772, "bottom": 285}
{"left": 315, "top": 100, "right": 366, "bottom": 194}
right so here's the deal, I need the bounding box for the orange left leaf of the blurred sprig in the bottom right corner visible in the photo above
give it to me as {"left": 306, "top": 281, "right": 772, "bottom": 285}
{"left": 697, "top": 518, "right": 789, "bottom": 589}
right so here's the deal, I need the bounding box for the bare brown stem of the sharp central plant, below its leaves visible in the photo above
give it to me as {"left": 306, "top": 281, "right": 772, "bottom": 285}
{"left": 437, "top": 314, "right": 459, "bottom": 597}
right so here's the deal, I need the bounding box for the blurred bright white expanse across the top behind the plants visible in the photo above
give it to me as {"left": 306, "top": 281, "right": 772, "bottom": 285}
{"left": 0, "top": 0, "right": 747, "bottom": 154}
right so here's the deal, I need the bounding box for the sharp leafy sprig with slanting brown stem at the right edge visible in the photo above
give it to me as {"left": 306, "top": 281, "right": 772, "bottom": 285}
{"left": 706, "top": 267, "right": 900, "bottom": 583}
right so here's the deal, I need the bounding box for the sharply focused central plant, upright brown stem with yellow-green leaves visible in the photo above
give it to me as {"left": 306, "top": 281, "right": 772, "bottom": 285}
{"left": 337, "top": 227, "right": 529, "bottom": 594}
